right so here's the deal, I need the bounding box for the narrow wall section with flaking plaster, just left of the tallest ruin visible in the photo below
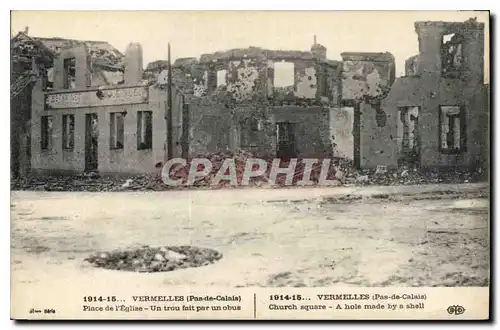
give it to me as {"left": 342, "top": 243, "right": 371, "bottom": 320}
{"left": 338, "top": 52, "right": 396, "bottom": 168}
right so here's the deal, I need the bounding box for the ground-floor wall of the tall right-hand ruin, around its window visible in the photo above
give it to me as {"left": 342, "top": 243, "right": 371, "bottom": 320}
{"left": 383, "top": 77, "right": 489, "bottom": 167}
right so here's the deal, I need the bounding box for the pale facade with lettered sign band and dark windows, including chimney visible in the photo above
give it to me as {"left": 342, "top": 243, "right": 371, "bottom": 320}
{"left": 31, "top": 44, "right": 182, "bottom": 174}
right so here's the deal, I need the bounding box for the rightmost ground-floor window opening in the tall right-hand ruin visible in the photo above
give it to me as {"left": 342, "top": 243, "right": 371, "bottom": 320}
{"left": 440, "top": 106, "right": 465, "bottom": 153}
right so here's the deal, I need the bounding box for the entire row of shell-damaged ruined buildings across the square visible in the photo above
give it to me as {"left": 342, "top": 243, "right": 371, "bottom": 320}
{"left": 13, "top": 17, "right": 489, "bottom": 178}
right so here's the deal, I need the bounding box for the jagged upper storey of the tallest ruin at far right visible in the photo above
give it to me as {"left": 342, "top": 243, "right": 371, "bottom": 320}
{"left": 406, "top": 18, "right": 484, "bottom": 82}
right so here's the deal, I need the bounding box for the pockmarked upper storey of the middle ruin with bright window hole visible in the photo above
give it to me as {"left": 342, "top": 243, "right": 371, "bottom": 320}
{"left": 145, "top": 43, "right": 342, "bottom": 104}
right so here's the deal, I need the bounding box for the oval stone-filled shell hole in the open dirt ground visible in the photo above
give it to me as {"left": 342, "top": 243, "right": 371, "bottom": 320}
{"left": 84, "top": 245, "right": 222, "bottom": 273}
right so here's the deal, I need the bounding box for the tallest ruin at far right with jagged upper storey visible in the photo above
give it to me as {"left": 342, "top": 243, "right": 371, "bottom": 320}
{"left": 383, "top": 19, "right": 489, "bottom": 169}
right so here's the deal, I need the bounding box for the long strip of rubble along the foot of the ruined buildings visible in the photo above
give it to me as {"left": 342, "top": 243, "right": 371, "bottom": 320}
{"left": 11, "top": 151, "right": 488, "bottom": 192}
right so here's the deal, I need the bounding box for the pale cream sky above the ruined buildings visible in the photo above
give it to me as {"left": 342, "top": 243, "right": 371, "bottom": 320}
{"left": 11, "top": 11, "right": 489, "bottom": 80}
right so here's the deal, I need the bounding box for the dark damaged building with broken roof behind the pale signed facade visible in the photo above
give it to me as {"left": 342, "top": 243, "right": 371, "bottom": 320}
{"left": 11, "top": 29, "right": 124, "bottom": 177}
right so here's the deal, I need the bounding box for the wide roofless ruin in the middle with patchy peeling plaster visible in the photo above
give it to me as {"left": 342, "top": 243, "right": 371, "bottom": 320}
{"left": 145, "top": 42, "right": 395, "bottom": 163}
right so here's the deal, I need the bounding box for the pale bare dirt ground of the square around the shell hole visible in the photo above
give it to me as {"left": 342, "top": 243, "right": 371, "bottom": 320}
{"left": 11, "top": 184, "right": 490, "bottom": 290}
